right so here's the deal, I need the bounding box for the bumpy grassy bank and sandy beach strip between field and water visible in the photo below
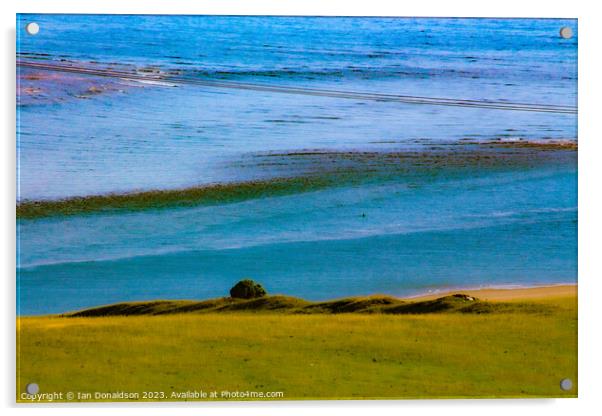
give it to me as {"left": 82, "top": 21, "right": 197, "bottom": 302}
{"left": 17, "top": 284, "right": 578, "bottom": 319}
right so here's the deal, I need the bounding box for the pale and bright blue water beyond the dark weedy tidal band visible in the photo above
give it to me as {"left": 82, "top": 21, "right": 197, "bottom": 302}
{"left": 18, "top": 15, "right": 577, "bottom": 199}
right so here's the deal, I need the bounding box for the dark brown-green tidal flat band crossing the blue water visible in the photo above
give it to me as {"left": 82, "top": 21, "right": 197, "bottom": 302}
{"left": 16, "top": 141, "right": 577, "bottom": 219}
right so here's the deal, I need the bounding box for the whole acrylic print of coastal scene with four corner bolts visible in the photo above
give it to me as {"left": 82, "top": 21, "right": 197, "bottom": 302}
{"left": 16, "top": 14, "right": 577, "bottom": 403}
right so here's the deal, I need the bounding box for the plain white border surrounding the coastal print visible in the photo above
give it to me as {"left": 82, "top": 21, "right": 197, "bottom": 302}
{"left": 0, "top": 0, "right": 602, "bottom": 416}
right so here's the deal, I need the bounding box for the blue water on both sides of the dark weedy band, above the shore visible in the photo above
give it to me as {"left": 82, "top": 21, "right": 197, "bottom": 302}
{"left": 17, "top": 15, "right": 577, "bottom": 314}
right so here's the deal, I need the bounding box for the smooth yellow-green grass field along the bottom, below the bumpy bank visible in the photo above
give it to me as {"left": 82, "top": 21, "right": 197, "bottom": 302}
{"left": 17, "top": 297, "right": 577, "bottom": 402}
